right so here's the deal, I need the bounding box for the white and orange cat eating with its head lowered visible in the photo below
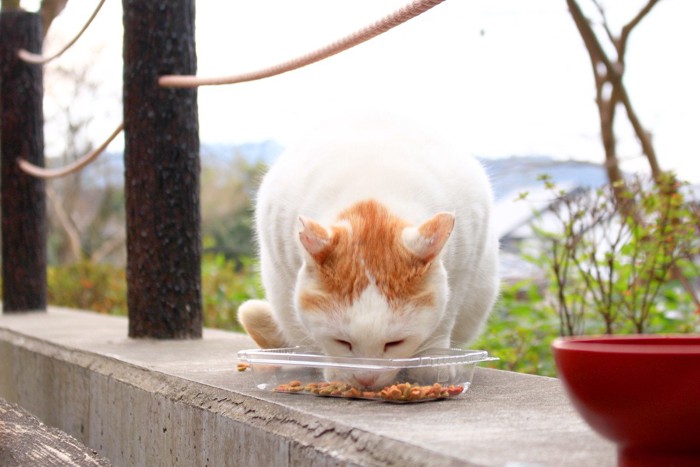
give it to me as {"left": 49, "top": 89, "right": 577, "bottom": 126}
{"left": 238, "top": 115, "right": 499, "bottom": 387}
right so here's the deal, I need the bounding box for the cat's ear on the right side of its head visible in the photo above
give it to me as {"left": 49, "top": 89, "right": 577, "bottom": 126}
{"left": 401, "top": 212, "right": 455, "bottom": 263}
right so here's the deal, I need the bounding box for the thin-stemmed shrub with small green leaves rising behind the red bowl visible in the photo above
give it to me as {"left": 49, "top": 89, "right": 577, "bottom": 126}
{"left": 531, "top": 175, "right": 700, "bottom": 335}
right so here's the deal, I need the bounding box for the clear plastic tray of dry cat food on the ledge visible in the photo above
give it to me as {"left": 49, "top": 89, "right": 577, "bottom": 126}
{"left": 238, "top": 347, "right": 497, "bottom": 403}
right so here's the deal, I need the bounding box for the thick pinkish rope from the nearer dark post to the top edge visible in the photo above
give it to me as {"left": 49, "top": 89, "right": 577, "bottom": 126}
{"left": 158, "top": 0, "right": 444, "bottom": 88}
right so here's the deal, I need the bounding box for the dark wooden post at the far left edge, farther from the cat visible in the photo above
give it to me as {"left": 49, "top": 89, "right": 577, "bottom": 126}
{"left": 0, "top": 10, "right": 47, "bottom": 313}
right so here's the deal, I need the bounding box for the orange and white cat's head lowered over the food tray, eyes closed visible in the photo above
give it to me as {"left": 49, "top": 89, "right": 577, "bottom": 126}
{"left": 295, "top": 201, "right": 455, "bottom": 387}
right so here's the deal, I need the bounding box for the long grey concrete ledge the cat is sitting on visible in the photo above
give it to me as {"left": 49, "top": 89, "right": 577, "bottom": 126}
{"left": 0, "top": 308, "right": 616, "bottom": 466}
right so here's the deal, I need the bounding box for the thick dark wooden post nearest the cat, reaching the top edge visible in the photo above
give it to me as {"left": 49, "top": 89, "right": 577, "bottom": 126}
{"left": 123, "top": 0, "right": 202, "bottom": 338}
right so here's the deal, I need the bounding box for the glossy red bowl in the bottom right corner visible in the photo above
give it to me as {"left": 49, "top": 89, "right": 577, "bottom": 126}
{"left": 552, "top": 335, "right": 700, "bottom": 466}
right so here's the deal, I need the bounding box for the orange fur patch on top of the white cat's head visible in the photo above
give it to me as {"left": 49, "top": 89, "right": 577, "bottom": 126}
{"left": 300, "top": 200, "right": 451, "bottom": 311}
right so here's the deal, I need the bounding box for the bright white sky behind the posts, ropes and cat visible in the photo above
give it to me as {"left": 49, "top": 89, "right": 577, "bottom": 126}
{"left": 30, "top": 0, "right": 700, "bottom": 182}
